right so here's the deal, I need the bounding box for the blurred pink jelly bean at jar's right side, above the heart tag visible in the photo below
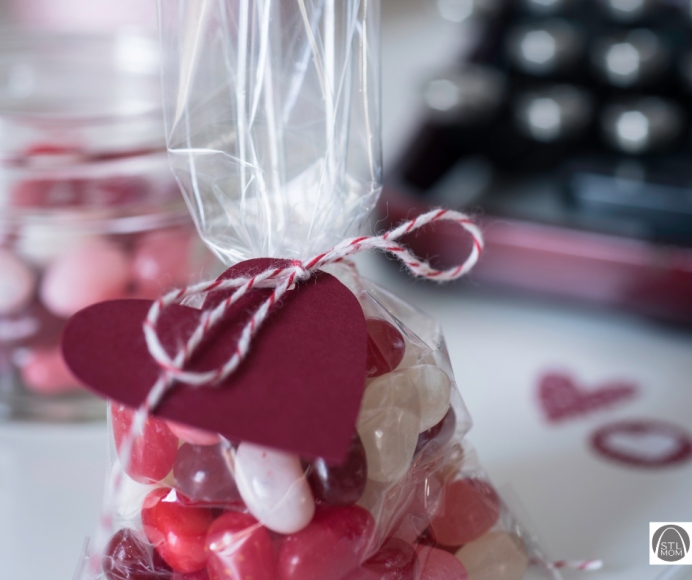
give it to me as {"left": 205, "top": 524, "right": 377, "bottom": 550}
{"left": 132, "top": 230, "right": 192, "bottom": 298}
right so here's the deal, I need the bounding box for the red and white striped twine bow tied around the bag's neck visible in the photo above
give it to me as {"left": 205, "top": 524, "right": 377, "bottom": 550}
{"left": 144, "top": 209, "right": 483, "bottom": 411}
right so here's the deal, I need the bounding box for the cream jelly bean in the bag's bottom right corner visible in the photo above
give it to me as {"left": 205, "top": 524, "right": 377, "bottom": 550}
{"left": 456, "top": 531, "right": 528, "bottom": 580}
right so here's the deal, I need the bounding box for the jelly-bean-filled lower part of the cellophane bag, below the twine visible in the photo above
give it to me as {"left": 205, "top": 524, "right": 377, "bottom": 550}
{"left": 93, "top": 264, "right": 547, "bottom": 580}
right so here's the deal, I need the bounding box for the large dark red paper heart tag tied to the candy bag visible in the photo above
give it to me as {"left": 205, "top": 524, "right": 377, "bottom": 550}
{"left": 62, "top": 258, "right": 367, "bottom": 461}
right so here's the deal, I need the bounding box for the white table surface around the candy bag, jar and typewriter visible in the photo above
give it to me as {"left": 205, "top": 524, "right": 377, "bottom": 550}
{"left": 0, "top": 0, "right": 692, "bottom": 580}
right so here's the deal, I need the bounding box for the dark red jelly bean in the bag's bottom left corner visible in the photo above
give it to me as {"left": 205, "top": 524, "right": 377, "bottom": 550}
{"left": 101, "top": 528, "right": 170, "bottom": 580}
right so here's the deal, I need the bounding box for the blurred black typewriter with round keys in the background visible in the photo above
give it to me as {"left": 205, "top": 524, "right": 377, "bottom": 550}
{"left": 380, "top": 0, "right": 692, "bottom": 323}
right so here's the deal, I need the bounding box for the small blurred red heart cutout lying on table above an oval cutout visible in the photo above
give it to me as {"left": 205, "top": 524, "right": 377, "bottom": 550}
{"left": 538, "top": 373, "right": 637, "bottom": 422}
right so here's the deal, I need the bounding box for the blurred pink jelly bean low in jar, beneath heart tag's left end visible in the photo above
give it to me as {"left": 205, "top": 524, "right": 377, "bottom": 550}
{"left": 20, "top": 347, "right": 79, "bottom": 395}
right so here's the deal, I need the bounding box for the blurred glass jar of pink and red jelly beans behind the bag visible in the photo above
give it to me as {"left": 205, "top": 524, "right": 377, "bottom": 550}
{"left": 0, "top": 31, "right": 211, "bottom": 420}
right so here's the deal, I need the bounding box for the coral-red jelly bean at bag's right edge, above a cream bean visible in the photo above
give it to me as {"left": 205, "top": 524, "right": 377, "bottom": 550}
{"left": 430, "top": 479, "right": 500, "bottom": 546}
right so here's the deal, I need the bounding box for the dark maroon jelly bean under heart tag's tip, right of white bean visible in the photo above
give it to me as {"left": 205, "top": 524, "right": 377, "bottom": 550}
{"left": 308, "top": 433, "right": 368, "bottom": 505}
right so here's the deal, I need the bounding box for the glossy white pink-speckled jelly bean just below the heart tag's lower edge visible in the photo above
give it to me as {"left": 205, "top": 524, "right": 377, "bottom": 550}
{"left": 235, "top": 443, "right": 315, "bottom": 534}
